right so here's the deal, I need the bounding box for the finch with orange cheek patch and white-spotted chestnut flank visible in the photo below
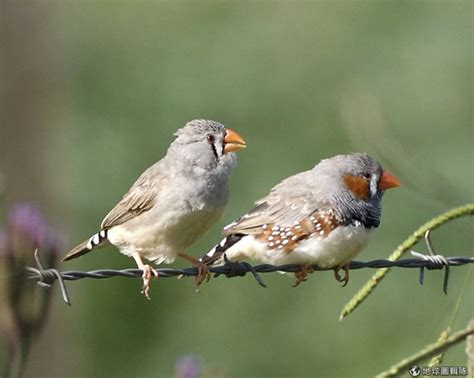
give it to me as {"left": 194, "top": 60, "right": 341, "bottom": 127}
{"left": 200, "top": 153, "right": 400, "bottom": 286}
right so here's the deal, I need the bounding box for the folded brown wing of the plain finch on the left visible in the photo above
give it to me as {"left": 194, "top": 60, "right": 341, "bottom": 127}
{"left": 101, "top": 166, "right": 163, "bottom": 229}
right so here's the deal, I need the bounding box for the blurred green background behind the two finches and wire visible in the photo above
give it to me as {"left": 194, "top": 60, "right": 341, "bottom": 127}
{"left": 0, "top": 1, "right": 474, "bottom": 377}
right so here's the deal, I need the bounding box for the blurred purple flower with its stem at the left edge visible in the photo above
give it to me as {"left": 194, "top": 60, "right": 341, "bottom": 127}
{"left": 0, "top": 204, "right": 61, "bottom": 376}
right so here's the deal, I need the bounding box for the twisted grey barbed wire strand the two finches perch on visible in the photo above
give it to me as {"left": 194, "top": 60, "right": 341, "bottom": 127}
{"left": 25, "top": 250, "right": 474, "bottom": 305}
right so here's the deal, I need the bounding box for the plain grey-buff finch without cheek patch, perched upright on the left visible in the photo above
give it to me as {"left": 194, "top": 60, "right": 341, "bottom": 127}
{"left": 63, "top": 119, "right": 246, "bottom": 299}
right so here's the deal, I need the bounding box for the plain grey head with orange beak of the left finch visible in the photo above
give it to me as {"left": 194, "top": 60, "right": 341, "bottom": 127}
{"left": 168, "top": 119, "right": 246, "bottom": 172}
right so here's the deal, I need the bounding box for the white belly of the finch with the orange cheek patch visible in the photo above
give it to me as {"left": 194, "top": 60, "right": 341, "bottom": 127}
{"left": 226, "top": 226, "right": 373, "bottom": 268}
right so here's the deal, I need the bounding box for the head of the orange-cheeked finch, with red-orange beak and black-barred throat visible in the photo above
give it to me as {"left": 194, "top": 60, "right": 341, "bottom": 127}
{"left": 312, "top": 153, "right": 400, "bottom": 228}
